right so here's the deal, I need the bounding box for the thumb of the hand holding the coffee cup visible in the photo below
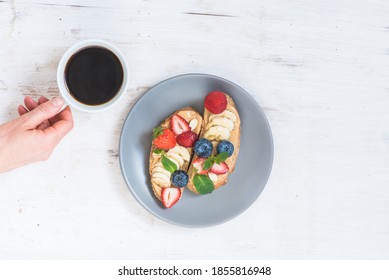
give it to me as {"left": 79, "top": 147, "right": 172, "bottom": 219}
{"left": 23, "top": 97, "right": 64, "bottom": 127}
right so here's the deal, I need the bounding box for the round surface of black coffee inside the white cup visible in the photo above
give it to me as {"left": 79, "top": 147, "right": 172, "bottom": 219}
{"left": 65, "top": 46, "right": 124, "bottom": 105}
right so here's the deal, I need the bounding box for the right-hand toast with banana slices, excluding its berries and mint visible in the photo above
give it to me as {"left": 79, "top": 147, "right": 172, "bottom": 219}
{"left": 187, "top": 94, "right": 240, "bottom": 194}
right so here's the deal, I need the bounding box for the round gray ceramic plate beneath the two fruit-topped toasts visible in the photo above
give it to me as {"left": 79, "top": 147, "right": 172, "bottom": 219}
{"left": 119, "top": 74, "right": 273, "bottom": 227}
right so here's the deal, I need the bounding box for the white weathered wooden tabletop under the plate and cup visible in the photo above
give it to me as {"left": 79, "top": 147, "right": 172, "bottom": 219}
{"left": 0, "top": 0, "right": 389, "bottom": 259}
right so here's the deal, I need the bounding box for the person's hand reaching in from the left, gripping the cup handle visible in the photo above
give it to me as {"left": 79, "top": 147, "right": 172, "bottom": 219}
{"left": 0, "top": 96, "right": 74, "bottom": 173}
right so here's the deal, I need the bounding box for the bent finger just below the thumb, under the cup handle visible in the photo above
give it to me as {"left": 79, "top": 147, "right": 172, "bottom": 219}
{"left": 44, "top": 106, "right": 74, "bottom": 142}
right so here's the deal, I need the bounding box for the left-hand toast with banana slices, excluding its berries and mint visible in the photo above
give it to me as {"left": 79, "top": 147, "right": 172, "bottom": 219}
{"left": 149, "top": 107, "right": 203, "bottom": 206}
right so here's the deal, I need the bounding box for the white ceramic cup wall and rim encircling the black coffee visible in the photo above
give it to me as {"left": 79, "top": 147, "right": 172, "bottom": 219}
{"left": 57, "top": 39, "right": 128, "bottom": 112}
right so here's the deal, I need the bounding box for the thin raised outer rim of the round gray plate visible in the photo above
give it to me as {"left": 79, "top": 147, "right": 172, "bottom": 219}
{"left": 118, "top": 72, "right": 274, "bottom": 228}
